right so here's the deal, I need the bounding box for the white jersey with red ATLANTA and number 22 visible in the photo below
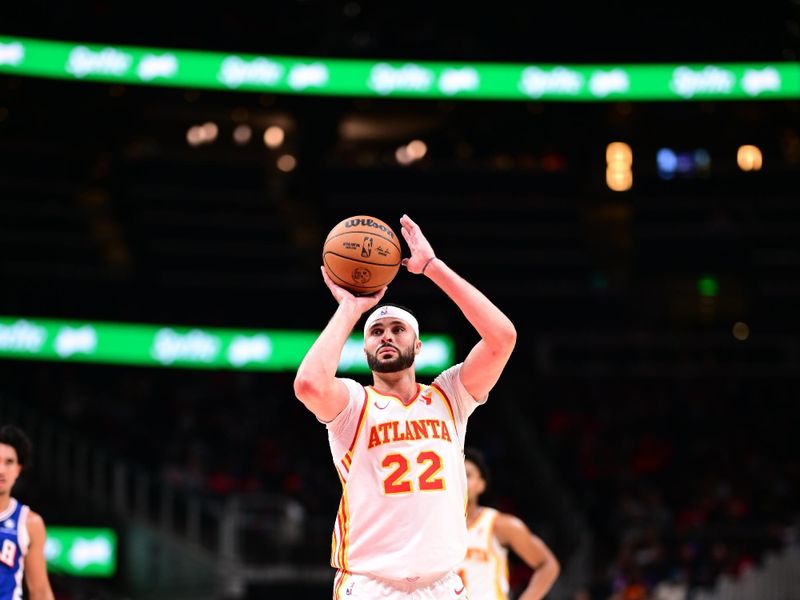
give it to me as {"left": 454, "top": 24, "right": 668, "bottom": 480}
{"left": 328, "top": 364, "right": 485, "bottom": 582}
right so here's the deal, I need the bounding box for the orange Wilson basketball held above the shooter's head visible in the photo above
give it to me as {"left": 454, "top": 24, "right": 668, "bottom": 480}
{"left": 322, "top": 215, "right": 401, "bottom": 294}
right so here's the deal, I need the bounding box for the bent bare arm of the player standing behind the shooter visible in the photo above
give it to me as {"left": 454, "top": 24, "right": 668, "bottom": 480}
{"left": 494, "top": 513, "right": 561, "bottom": 600}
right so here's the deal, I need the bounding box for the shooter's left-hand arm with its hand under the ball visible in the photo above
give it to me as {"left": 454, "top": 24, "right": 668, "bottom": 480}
{"left": 294, "top": 268, "right": 386, "bottom": 422}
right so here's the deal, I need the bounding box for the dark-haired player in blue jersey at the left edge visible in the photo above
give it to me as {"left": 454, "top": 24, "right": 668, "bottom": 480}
{"left": 0, "top": 425, "right": 53, "bottom": 600}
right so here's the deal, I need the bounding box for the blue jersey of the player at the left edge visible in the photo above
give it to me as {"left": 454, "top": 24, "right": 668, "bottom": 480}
{"left": 0, "top": 498, "right": 30, "bottom": 600}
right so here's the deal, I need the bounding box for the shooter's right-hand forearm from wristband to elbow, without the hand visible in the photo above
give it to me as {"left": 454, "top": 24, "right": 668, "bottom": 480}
{"left": 425, "top": 258, "right": 517, "bottom": 351}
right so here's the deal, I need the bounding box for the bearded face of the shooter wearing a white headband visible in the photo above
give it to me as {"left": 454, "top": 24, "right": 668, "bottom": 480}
{"left": 364, "top": 317, "right": 422, "bottom": 373}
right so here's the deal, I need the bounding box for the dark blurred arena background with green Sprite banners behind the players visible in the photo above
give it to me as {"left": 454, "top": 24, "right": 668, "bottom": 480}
{"left": 0, "top": 0, "right": 800, "bottom": 600}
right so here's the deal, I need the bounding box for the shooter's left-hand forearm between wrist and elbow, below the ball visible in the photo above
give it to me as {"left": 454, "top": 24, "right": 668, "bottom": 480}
{"left": 295, "top": 302, "right": 361, "bottom": 389}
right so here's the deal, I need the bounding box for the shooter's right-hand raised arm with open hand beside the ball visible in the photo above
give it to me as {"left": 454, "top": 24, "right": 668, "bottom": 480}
{"left": 400, "top": 215, "right": 517, "bottom": 398}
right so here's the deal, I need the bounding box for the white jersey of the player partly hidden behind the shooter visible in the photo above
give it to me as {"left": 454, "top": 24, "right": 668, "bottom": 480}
{"left": 459, "top": 507, "right": 508, "bottom": 600}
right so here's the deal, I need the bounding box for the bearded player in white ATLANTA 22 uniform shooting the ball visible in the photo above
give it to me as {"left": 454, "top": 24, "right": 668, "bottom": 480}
{"left": 294, "top": 215, "right": 516, "bottom": 600}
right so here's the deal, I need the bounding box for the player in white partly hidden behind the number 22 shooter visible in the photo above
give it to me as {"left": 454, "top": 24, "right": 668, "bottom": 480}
{"left": 459, "top": 448, "right": 560, "bottom": 600}
